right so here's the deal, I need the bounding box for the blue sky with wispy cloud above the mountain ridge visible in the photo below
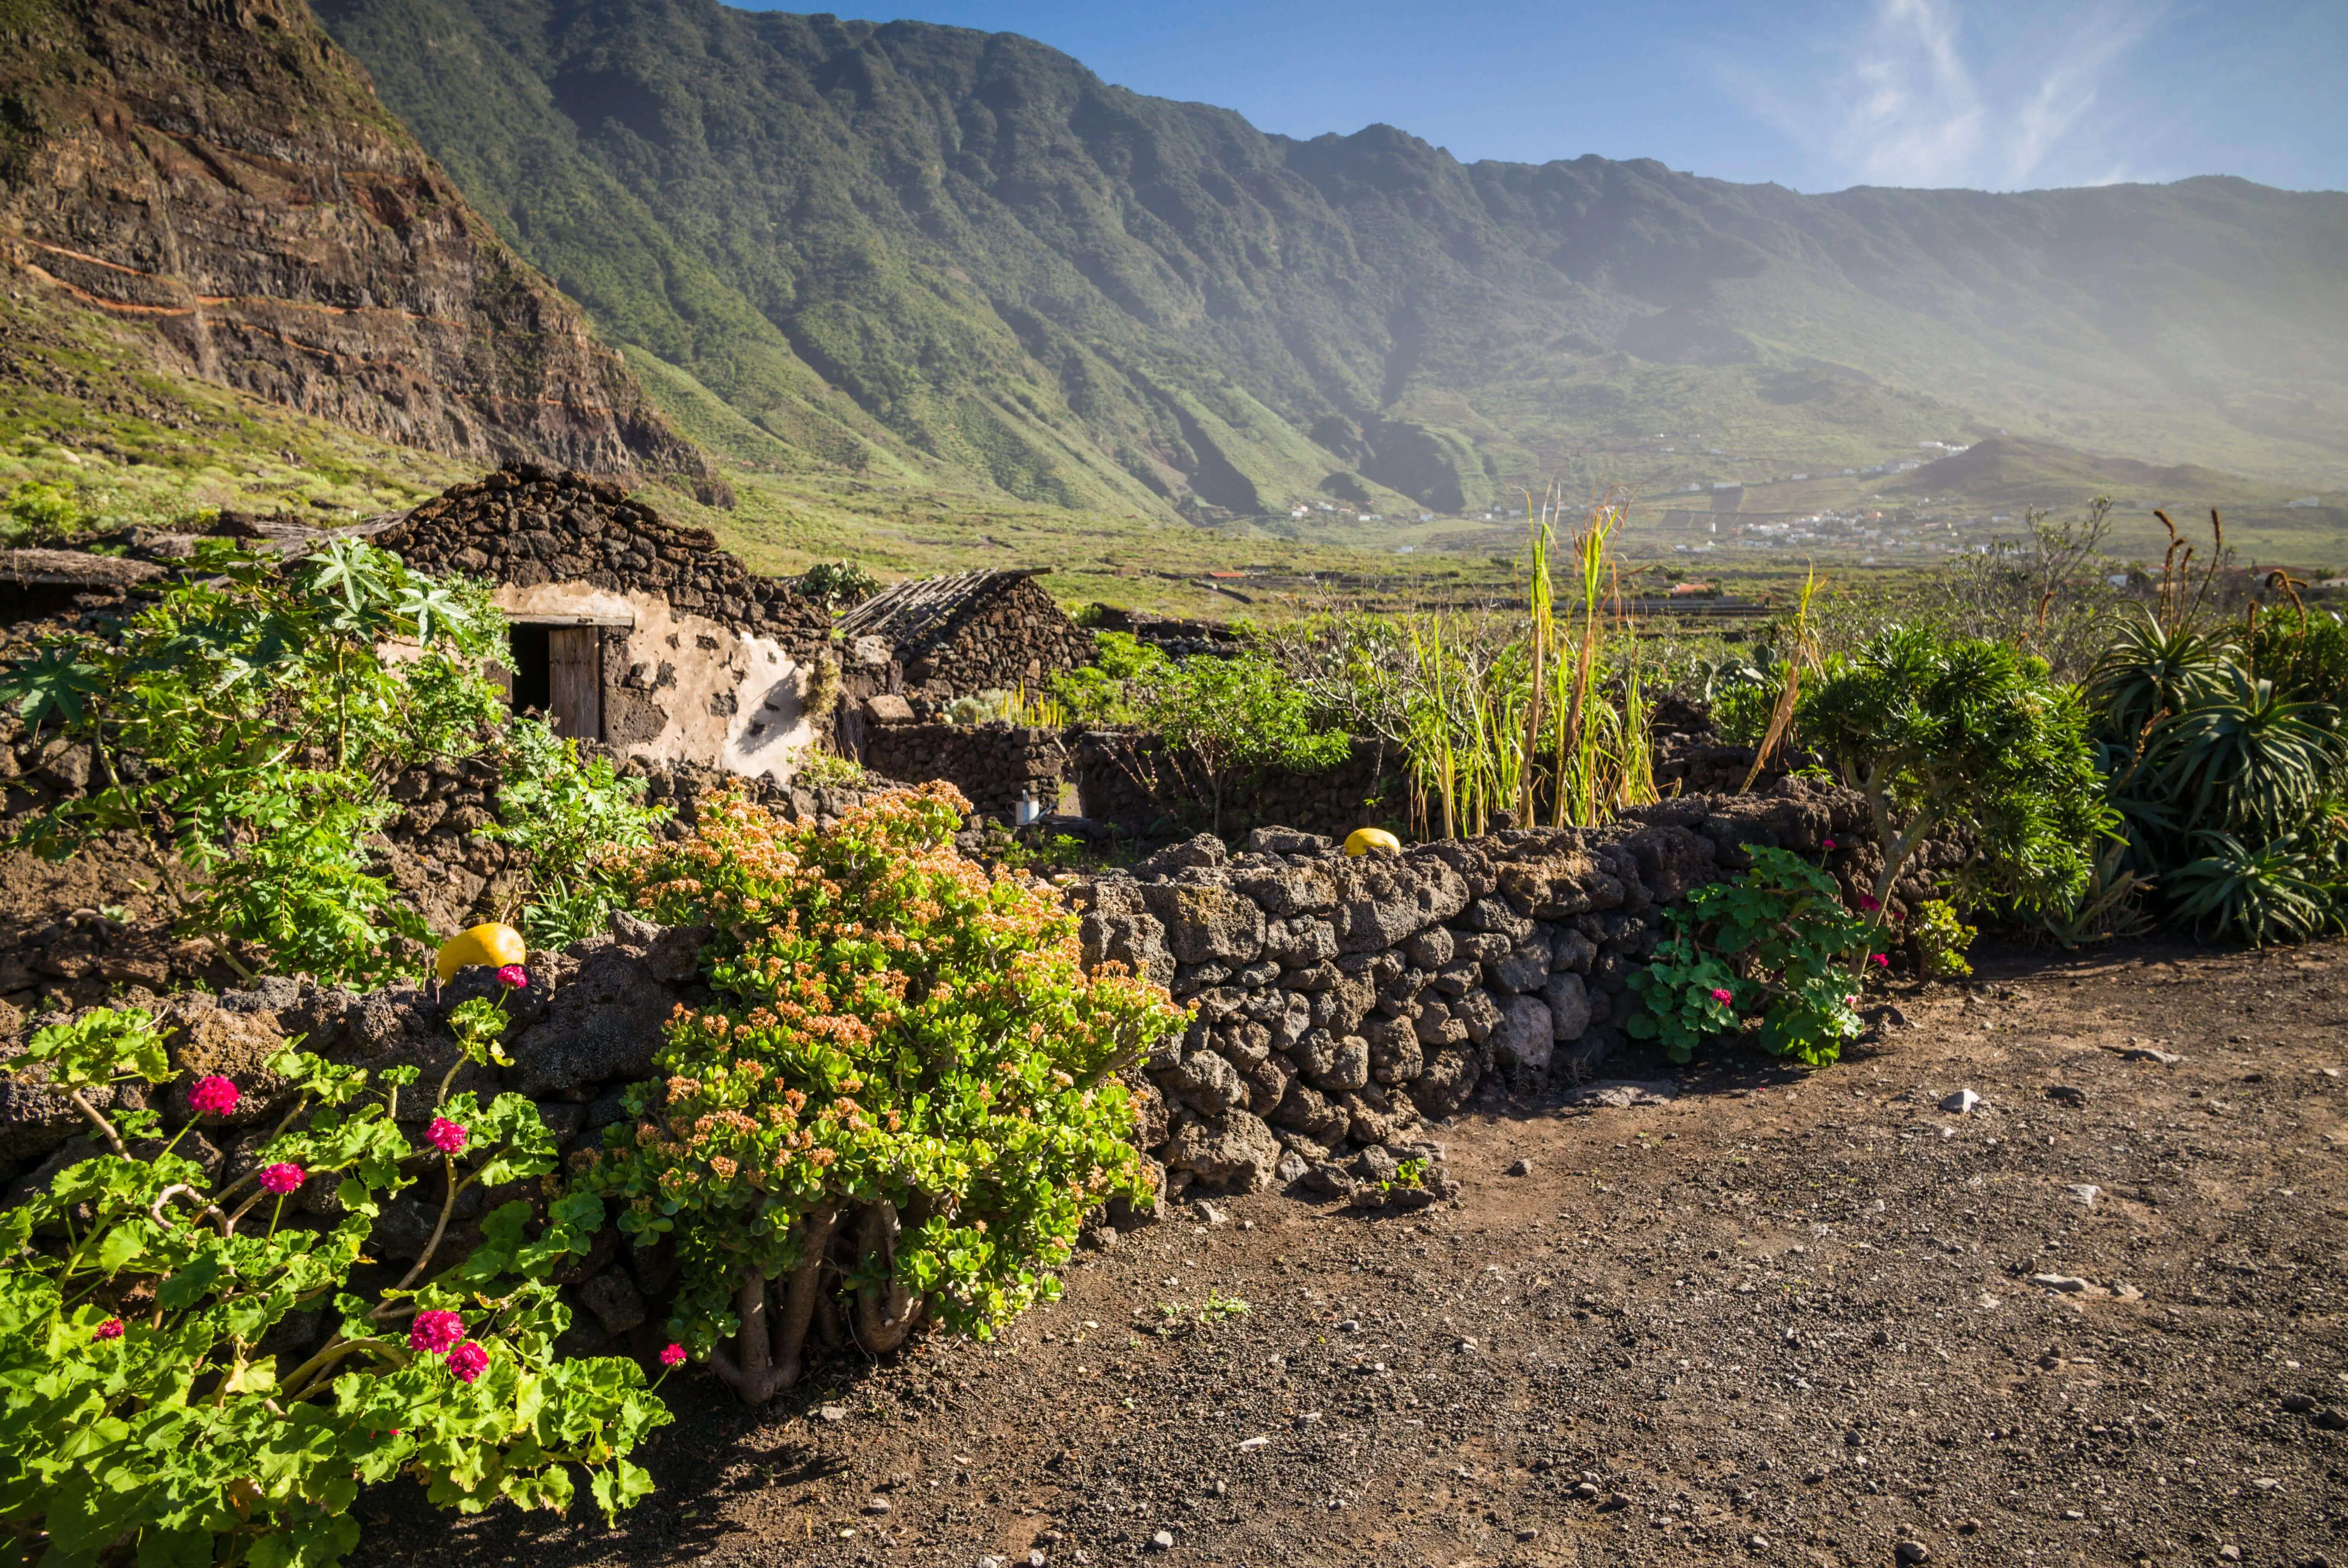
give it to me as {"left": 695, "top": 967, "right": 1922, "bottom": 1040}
{"left": 756, "top": 0, "right": 2348, "bottom": 190}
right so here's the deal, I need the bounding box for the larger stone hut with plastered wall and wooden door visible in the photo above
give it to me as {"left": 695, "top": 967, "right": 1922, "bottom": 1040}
{"left": 376, "top": 465, "right": 838, "bottom": 782}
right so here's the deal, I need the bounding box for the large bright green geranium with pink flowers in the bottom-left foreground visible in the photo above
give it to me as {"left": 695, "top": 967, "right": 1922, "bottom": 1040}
{"left": 0, "top": 1003, "right": 667, "bottom": 1568}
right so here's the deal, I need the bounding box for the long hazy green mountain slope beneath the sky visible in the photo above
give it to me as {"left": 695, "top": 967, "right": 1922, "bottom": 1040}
{"left": 319, "top": 0, "right": 2348, "bottom": 519}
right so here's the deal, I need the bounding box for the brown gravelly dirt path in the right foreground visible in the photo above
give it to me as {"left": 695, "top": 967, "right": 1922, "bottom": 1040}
{"left": 362, "top": 944, "right": 2348, "bottom": 1568}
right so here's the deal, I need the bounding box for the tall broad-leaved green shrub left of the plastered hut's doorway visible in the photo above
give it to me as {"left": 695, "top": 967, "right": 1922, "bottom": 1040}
{"left": 0, "top": 540, "right": 502, "bottom": 984}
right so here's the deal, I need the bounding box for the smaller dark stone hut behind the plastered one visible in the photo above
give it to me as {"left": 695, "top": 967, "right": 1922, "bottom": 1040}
{"left": 836, "top": 568, "right": 1094, "bottom": 718}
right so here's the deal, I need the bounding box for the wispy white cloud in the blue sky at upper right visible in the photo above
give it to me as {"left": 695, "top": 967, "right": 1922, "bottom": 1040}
{"left": 1719, "top": 0, "right": 2160, "bottom": 190}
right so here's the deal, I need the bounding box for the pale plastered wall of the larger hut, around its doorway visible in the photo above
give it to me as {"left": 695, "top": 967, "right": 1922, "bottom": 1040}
{"left": 496, "top": 582, "right": 815, "bottom": 784}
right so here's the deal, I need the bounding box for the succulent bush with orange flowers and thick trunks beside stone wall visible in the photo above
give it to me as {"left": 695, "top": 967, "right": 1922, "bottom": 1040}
{"left": 575, "top": 784, "right": 1183, "bottom": 1404}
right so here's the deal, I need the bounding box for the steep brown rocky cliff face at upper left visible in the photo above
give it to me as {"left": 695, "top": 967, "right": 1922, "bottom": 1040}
{"left": 0, "top": 0, "right": 716, "bottom": 498}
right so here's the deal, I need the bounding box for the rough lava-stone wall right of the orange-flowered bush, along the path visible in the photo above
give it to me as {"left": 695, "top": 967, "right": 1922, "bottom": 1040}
{"left": 1075, "top": 779, "right": 1867, "bottom": 1192}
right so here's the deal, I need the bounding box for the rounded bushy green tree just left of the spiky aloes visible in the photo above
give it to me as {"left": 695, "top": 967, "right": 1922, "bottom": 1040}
{"left": 1794, "top": 627, "right": 2109, "bottom": 909}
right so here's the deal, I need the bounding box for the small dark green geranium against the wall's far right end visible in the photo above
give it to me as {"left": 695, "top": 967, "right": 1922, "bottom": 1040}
{"left": 1625, "top": 850, "right": 1883, "bottom": 1068}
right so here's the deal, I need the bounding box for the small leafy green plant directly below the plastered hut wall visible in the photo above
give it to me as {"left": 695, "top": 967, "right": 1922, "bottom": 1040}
{"left": 482, "top": 718, "right": 669, "bottom": 948}
